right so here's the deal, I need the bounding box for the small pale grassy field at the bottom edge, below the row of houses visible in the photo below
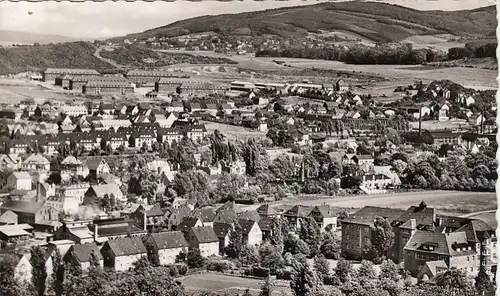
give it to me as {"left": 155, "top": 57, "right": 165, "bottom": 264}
{"left": 180, "top": 273, "right": 290, "bottom": 295}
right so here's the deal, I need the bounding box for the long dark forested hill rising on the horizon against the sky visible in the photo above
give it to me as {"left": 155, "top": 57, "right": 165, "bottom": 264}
{"left": 113, "top": 1, "right": 497, "bottom": 42}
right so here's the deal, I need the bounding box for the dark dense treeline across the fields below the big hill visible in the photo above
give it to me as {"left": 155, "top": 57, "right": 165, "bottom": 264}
{"left": 255, "top": 44, "right": 446, "bottom": 65}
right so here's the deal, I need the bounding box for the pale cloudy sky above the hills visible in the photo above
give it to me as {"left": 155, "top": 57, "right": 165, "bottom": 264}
{"left": 0, "top": 0, "right": 495, "bottom": 39}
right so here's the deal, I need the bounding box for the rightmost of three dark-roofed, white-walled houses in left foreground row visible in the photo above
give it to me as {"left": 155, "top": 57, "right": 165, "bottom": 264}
{"left": 185, "top": 226, "right": 219, "bottom": 257}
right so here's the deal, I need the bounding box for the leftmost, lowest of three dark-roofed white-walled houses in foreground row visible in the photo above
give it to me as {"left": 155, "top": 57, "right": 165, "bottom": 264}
{"left": 101, "top": 237, "right": 147, "bottom": 271}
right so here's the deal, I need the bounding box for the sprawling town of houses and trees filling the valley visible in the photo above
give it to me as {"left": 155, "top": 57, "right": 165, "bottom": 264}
{"left": 0, "top": 60, "right": 497, "bottom": 295}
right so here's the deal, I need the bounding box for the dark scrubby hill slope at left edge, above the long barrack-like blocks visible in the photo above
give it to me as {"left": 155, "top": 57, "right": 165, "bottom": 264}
{"left": 0, "top": 41, "right": 113, "bottom": 75}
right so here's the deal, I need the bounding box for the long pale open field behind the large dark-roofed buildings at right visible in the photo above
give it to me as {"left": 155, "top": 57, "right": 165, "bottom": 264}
{"left": 270, "top": 190, "right": 497, "bottom": 215}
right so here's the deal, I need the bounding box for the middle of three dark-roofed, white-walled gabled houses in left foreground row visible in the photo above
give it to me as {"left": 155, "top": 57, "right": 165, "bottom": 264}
{"left": 144, "top": 231, "right": 189, "bottom": 265}
